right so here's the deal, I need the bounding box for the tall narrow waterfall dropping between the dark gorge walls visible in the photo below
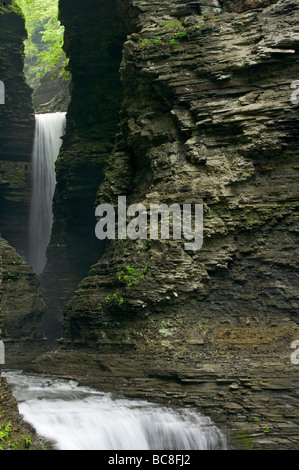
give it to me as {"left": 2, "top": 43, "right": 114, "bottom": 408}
{"left": 29, "top": 113, "right": 66, "bottom": 274}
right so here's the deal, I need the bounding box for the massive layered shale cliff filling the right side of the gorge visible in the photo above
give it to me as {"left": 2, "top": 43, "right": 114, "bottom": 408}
{"left": 36, "top": 0, "right": 299, "bottom": 449}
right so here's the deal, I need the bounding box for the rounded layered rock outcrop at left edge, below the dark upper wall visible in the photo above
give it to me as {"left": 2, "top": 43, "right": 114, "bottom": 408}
{"left": 0, "top": 239, "right": 46, "bottom": 368}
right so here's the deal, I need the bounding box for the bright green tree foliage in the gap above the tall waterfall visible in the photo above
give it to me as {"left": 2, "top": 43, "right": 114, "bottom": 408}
{"left": 15, "top": 0, "right": 69, "bottom": 88}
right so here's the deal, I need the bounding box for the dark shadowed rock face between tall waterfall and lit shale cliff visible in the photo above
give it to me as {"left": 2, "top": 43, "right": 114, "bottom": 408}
{"left": 41, "top": 0, "right": 131, "bottom": 344}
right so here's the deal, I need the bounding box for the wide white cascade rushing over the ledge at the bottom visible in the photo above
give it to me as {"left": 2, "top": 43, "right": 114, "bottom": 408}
{"left": 3, "top": 371, "right": 226, "bottom": 450}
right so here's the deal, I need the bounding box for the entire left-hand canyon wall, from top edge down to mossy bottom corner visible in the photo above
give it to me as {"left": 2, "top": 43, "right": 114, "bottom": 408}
{"left": 0, "top": 0, "right": 51, "bottom": 450}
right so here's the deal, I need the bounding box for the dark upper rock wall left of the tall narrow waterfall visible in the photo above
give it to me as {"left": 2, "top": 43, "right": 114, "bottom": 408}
{"left": 0, "top": 2, "right": 35, "bottom": 256}
